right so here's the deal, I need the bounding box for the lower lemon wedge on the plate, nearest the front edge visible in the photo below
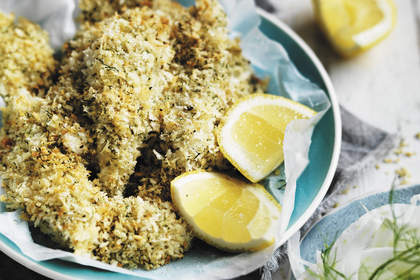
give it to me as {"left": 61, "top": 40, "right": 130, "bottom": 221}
{"left": 171, "top": 171, "right": 281, "bottom": 252}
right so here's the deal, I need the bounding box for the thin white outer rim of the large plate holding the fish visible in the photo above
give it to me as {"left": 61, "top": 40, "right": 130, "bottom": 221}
{"left": 0, "top": 8, "right": 341, "bottom": 280}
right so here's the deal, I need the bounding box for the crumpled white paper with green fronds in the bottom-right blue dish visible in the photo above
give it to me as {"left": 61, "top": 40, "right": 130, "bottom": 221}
{"left": 288, "top": 195, "right": 420, "bottom": 280}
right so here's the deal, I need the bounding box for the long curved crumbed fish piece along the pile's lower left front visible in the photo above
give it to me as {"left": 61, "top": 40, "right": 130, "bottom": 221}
{"left": 0, "top": 91, "right": 192, "bottom": 269}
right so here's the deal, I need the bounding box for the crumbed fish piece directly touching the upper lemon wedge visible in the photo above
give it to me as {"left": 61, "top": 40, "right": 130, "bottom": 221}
{"left": 131, "top": 1, "right": 266, "bottom": 198}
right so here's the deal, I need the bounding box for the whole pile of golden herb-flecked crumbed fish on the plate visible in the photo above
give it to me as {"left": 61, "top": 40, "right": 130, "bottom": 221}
{"left": 0, "top": 0, "right": 264, "bottom": 269}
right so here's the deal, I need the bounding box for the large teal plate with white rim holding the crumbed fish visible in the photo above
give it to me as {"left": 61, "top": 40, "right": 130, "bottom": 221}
{"left": 0, "top": 10, "right": 341, "bottom": 280}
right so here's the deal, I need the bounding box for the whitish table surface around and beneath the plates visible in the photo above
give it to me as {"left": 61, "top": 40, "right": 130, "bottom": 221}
{"left": 0, "top": 0, "right": 420, "bottom": 280}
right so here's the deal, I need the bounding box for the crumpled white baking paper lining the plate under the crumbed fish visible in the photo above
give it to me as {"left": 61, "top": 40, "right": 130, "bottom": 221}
{"left": 0, "top": 0, "right": 330, "bottom": 279}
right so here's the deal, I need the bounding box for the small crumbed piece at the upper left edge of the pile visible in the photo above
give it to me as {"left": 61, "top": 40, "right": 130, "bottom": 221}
{"left": 0, "top": 12, "right": 57, "bottom": 97}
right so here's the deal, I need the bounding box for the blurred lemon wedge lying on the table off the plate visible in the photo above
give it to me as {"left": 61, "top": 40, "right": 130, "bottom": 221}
{"left": 313, "top": 0, "right": 397, "bottom": 57}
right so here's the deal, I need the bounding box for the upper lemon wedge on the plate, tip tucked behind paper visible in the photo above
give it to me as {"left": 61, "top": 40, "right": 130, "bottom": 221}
{"left": 217, "top": 94, "right": 315, "bottom": 183}
